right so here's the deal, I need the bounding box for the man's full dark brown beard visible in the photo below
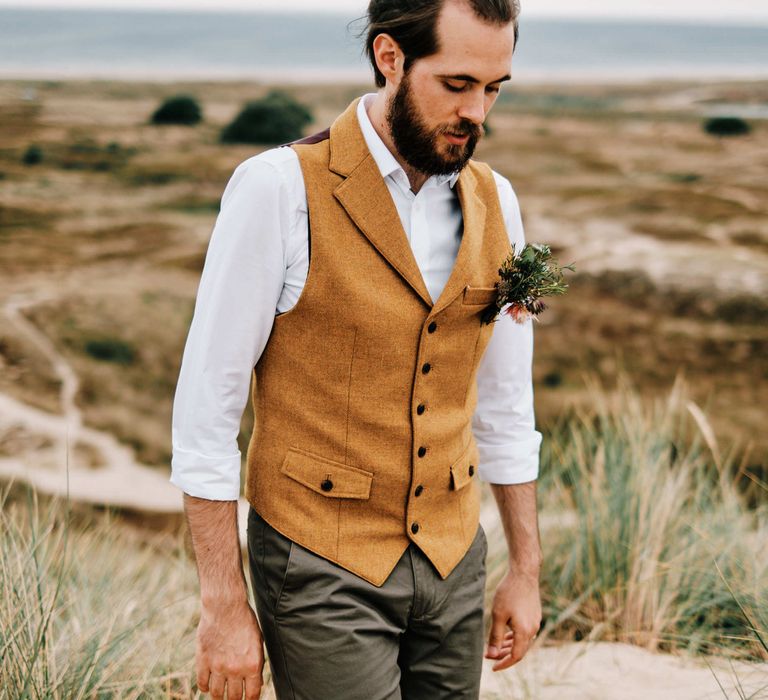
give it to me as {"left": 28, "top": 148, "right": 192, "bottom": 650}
{"left": 387, "top": 73, "right": 483, "bottom": 175}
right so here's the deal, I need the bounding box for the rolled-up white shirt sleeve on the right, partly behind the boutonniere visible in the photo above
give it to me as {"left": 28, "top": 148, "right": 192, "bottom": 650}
{"left": 472, "top": 173, "right": 542, "bottom": 484}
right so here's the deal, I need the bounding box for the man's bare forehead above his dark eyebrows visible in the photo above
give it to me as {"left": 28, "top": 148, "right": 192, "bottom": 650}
{"left": 422, "top": 0, "right": 515, "bottom": 82}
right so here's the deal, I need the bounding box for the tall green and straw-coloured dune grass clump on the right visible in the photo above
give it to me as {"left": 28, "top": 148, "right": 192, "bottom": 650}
{"left": 510, "top": 375, "right": 768, "bottom": 660}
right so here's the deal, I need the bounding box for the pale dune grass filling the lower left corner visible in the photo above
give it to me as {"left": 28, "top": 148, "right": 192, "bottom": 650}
{"left": 0, "top": 490, "right": 197, "bottom": 700}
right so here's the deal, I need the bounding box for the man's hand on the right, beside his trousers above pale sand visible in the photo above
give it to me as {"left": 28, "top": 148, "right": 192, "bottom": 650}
{"left": 485, "top": 571, "right": 541, "bottom": 671}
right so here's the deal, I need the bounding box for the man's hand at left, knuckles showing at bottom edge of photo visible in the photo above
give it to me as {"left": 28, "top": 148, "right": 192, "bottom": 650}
{"left": 195, "top": 602, "right": 264, "bottom": 700}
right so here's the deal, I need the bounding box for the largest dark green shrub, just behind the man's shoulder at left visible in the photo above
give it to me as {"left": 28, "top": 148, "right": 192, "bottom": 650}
{"left": 221, "top": 90, "right": 312, "bottom": 144}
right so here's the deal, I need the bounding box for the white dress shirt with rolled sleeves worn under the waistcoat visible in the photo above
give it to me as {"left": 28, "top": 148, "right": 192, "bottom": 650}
{"left": 170, "top": 93, "right": 542, "bottom": 500}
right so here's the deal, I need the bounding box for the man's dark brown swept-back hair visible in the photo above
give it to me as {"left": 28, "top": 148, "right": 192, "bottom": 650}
{"left": 365, "top": 0, "right": 520, "bottom": 87}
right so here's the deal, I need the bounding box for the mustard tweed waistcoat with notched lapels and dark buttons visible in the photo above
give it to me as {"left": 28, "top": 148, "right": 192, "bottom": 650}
{"left": 246, "top": 98, "right": 512, "bottom": 586}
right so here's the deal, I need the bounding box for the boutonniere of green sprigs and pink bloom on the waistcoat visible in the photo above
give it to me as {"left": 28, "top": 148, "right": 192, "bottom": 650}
{"left": 482, "top": 243, "right": 575, "bottom": 323}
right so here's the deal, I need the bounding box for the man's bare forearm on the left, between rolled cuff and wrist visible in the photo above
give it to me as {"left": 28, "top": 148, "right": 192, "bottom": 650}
{"left": 184, "top": 493, "right": 248, "bottom": 605}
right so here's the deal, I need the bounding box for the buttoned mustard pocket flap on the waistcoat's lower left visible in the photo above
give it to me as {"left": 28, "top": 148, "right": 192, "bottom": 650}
{"left": 280, "top": 447, "right": 373, "bottom": 499}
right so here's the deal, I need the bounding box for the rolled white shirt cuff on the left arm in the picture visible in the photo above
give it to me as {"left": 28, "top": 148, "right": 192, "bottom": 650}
{"left": 169, "top": 448, "right": 241, "bottom": 501}
